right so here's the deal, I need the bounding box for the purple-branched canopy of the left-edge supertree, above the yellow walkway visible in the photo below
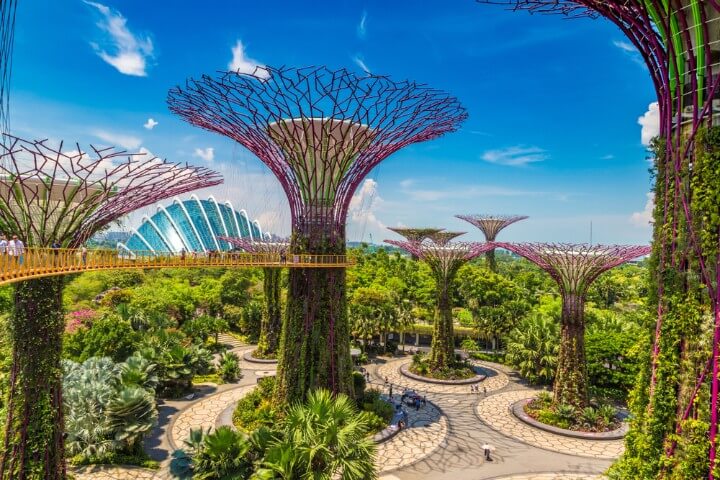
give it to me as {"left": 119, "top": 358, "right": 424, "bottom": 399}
{"left": 0, "top": 135, "right": 222, "bottom": 247}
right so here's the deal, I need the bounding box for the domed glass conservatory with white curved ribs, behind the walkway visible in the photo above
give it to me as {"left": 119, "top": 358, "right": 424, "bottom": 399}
{"left": 118, "top": 195, "right": 264, "bottom": 253}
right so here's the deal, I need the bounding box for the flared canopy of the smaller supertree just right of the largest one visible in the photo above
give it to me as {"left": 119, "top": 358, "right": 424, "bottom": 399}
{"left": 385, "top": 240, "right": 493, "bottom": 280}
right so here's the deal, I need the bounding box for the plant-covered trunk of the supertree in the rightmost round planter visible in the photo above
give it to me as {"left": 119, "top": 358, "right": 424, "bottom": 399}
{"left": 553, "top": 294, "right": 588, "bottom": 408}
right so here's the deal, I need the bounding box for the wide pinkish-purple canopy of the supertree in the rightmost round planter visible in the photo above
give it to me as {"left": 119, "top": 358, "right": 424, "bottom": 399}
{"left": 495, "top": 242, "right": 651, "bottom": 296}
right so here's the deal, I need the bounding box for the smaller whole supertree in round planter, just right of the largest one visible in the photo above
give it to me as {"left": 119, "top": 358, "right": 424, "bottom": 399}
{"left": 385, "top": 234, "right": 492, "bottom": 370}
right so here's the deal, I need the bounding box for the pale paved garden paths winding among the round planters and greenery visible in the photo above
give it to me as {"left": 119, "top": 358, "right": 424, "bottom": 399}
{"left": 74, "top": 345, "right": 622, "bottom": 480}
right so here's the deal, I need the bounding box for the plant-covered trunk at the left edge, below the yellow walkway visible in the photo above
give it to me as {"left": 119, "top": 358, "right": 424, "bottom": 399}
{"left": 0, "top": 277, "right": 66, "bottom": 480}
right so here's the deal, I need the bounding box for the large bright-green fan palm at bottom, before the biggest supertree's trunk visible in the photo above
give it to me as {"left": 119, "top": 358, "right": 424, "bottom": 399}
{"left": 253, "top": 390, "right": 377, "bottom": 480}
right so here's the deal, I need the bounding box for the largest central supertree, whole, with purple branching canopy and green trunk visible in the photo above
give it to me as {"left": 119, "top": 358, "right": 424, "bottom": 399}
{"left": 168, "top": 67, "right": 466, "bottom": 402}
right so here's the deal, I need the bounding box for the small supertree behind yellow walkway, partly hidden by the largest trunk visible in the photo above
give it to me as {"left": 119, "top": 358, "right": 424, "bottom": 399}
{"left": 218, "top": 237, "right": 290, "bottom": 357}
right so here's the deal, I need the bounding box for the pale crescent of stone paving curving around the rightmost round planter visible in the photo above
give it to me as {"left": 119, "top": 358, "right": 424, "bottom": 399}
{"left": 476, "top": 390, "right": 624, "bottom": 459}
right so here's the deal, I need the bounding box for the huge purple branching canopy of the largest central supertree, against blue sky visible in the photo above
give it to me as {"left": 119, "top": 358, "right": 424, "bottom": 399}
{"left": 168, "top": 67, "right": 467, "bottom": 231}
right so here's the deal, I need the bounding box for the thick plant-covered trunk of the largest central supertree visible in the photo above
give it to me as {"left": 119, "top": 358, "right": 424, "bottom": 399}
{"left": 275, "top": 231, "right": 353, "bottom": 403}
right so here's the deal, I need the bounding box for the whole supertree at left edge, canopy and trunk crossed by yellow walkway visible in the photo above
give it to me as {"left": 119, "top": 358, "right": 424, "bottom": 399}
{"left": 0, "top": 135, "right": 222, "bottom": 480}
